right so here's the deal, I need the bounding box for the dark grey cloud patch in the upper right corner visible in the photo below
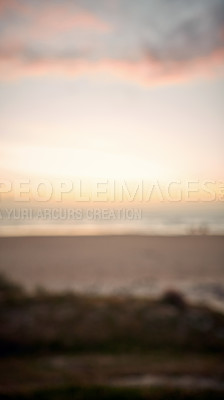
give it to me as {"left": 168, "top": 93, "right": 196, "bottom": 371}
{"left": 143, "top": 0, "right": 224, "bottom": 62}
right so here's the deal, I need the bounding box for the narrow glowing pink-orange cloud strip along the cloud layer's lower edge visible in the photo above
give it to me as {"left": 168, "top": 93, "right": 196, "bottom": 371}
{"left": 0, "top": 49, "right": 224, "bottom": 86}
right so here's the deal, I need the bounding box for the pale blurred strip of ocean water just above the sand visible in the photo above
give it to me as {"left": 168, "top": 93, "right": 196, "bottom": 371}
{"left": 0, "top": 202, "right": 224, "bottom": 236}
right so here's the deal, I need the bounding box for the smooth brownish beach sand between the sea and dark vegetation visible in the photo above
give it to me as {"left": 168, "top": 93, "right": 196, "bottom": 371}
{"left": 0, "top": 236, "right": 224, "bottom": 292}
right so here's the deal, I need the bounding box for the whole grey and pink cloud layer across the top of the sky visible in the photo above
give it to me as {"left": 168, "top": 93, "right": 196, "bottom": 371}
{"left": 0, "top": 0, "right": 224, "bottom": 86}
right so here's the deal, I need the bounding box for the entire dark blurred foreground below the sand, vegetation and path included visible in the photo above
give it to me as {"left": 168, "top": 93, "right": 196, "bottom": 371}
{"left": 0, "top": 276, "right": 224, "bottom": 400}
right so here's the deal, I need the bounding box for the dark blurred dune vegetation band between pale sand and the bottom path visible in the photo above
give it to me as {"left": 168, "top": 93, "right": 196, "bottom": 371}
{"left": 0, "top": 279, "right": 224, "bottom": 355}
